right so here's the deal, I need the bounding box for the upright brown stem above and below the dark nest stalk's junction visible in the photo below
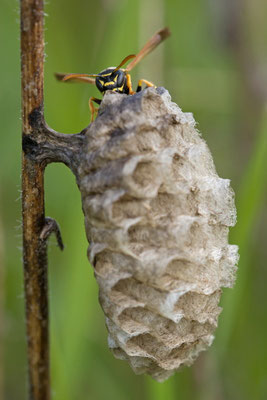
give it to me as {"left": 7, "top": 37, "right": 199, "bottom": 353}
{"left": 21, "top": 0, "right": 50, "bottom": 400}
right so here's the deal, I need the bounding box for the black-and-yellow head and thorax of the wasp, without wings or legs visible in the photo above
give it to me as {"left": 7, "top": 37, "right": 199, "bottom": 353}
{"left": 95, "top": 67, "right": 126, "bottom": 93}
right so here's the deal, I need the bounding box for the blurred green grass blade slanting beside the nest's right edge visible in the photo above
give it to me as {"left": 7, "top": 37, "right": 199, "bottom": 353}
{"left": 216, "top": 106, "right": 267, "bottom": 361}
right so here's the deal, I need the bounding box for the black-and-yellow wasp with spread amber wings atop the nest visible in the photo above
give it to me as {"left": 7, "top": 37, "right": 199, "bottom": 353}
{"left": 56, "top": 28, "right": 170, "bottom": 122}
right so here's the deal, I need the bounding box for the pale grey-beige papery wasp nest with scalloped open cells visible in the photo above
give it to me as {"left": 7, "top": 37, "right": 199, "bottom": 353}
{"left": 79, "top": 88, "right": 238, "bottom": 381}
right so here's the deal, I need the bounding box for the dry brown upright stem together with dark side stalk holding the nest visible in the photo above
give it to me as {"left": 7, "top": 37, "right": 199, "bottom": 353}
{"left": 21, "top": 0, "right": 83, "bottom": 400}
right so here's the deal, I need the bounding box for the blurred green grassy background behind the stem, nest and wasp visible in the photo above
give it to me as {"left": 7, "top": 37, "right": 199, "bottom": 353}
{"left": 0, "top": 0, "right": 267, "bottom": 400}
